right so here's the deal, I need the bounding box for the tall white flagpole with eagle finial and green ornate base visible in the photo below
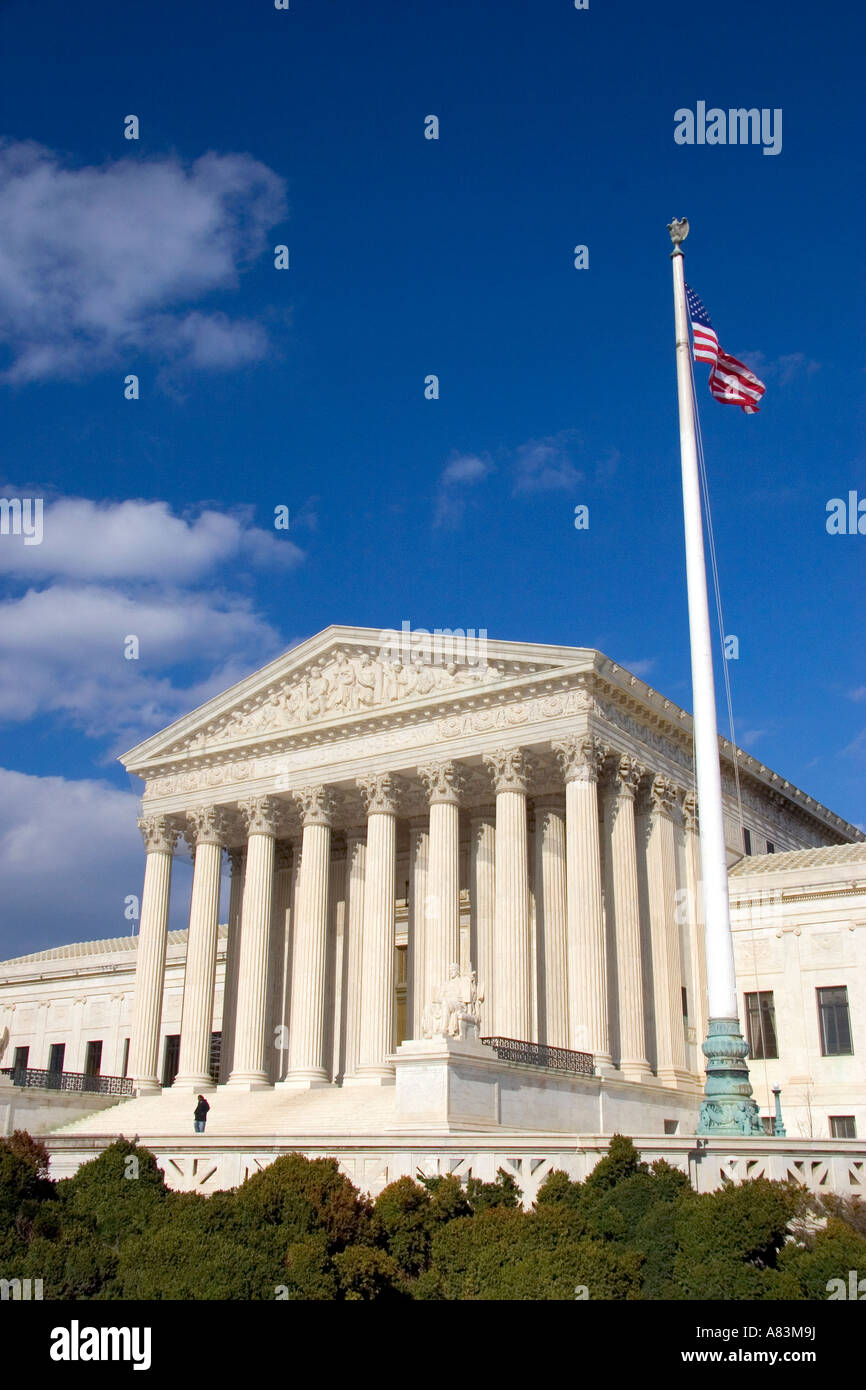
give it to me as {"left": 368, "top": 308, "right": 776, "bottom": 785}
{"left": 667, "top": 218, "right": 763, "bottom": 1136}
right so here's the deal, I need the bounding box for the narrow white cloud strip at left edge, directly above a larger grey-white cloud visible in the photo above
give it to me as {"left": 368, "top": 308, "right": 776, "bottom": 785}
{"left": 0, "top": 489, "right": 303, "bottom": 582}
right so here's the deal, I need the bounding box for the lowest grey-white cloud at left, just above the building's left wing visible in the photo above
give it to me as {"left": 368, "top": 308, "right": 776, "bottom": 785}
{"left": 0, "top": 769, "right": 190, "bottom": 959}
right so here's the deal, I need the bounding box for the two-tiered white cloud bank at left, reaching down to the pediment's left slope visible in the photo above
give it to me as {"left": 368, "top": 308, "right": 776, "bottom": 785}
{"left": 0, "top": 498, "right": 303, "bottom": 752}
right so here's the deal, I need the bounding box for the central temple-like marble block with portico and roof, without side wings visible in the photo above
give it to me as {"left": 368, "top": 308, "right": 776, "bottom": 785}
{"left": 8, "top": 627, "right": 863, "bottom": 1186}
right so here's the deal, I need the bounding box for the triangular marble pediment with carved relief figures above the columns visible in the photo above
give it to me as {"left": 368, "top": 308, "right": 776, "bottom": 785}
{"left": 122, "top": 628, "right": 594, "bottom": 771}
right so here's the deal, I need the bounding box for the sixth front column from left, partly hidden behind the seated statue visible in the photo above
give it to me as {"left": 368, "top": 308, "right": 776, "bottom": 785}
{"left": 418, "top": 762, "right": 463, "bottom": 1009}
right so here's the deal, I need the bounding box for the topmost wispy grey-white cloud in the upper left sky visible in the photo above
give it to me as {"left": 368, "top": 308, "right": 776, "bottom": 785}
{"left": 0, "top": 140, "right": 286, "bottom": 382}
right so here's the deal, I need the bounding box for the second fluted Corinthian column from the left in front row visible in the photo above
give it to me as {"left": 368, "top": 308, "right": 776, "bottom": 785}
{"left": 174, "top": 806, "right": 228, "bottom": 1091}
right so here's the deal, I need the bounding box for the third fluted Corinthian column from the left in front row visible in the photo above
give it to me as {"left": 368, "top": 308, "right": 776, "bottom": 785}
{"left": 228, "top": 796, "right": 279, "bottom": 1091}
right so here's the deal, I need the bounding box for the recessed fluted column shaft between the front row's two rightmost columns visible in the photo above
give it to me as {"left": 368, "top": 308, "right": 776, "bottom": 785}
{"left": 535, "top": 799, "right": 569, "bottom": 1047}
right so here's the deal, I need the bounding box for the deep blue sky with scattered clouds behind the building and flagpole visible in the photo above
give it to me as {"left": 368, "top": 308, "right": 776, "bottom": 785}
{"left": 0, "top": 0, "right": 866, "bottom": 955}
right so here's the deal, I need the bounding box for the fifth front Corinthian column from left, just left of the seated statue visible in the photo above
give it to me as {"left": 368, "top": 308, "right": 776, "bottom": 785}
{"left": 356, "top": 773, "right": 398, "bottom": 1084}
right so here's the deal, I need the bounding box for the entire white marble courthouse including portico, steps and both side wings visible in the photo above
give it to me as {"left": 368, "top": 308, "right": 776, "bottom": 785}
{"left": 0, "top": 627, "right": 866, "bottom": 1201}
